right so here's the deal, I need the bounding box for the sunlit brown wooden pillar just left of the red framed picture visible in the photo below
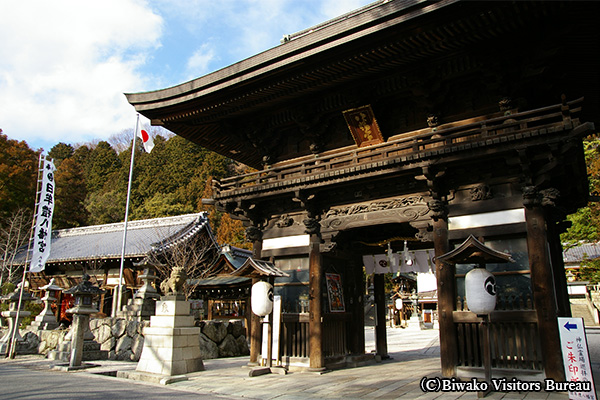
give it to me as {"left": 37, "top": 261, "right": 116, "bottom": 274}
{"left": 308, "top": 231, "right": 325, "bottom": 371}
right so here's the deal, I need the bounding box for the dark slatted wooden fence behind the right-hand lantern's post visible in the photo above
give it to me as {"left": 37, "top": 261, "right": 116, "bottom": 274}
{"left": 453, "top": 295, "right": 543, "bottom": 371}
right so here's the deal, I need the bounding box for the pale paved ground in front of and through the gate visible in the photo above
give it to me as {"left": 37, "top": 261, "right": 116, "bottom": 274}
{"left": 0, "top": 328, "right": 600, "bottom": 400}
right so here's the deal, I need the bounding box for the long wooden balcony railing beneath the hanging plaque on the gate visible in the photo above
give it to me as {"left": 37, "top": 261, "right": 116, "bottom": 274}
{"left": 213, "top": 99, "right": 583, "bottom": 198}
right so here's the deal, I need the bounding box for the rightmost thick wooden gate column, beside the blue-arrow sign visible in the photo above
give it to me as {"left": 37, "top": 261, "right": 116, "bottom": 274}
{"left": 523, "top": 186, "right": 565, "bottom": 381}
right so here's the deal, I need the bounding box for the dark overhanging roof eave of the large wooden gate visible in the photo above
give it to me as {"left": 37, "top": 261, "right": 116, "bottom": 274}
{"left": 127, "top": 0, "right": 598, "bottom": 168}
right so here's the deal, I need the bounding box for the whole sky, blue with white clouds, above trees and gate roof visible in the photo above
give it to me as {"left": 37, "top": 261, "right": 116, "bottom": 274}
{"left": 0, "top": 0, "right": 373, "bottom": 152}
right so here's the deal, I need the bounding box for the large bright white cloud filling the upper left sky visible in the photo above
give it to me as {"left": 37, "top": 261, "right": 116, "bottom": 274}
{"left": 0, "top": 0, "right": 162, "bottom": 150}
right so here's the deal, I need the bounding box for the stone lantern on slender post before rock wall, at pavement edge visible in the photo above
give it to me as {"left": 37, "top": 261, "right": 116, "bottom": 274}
{"left": 63, "top": 273, "right": 104, "bottom": 367}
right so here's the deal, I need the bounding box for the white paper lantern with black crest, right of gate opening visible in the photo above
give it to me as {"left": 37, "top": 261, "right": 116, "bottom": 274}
{"left": 465, "top": 268, "right": 496, "bottom": 314}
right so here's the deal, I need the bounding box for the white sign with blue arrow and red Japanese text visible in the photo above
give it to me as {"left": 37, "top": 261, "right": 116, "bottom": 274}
{"left": 558, "top": 317, "right": 597, "bottom": 400}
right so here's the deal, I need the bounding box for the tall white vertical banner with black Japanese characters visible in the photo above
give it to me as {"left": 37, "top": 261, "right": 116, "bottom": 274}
{"left": 29, "top": 158, "right": 56, "bottom": 272}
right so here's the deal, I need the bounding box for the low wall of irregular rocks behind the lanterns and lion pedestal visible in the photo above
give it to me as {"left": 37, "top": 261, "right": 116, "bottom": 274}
{"left": 9, "top": 318, "right": 250, "bottom": 362}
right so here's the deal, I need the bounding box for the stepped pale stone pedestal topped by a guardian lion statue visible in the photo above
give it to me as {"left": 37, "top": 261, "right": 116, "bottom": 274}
{"left": 123, "top": 267, "right": 204, "bottom": 384}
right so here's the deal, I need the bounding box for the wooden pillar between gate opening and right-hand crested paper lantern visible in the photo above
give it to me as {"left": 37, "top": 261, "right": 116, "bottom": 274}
{"left": 429, "top": 200, "right": 458, "bottom": 377}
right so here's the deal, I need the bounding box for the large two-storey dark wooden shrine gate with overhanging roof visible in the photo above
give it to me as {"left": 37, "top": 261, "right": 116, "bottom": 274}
{"left": 127, "top": 0, "right": 600, "bottom": 380}
